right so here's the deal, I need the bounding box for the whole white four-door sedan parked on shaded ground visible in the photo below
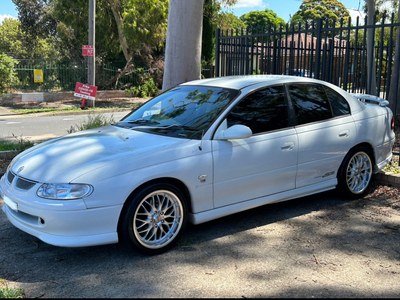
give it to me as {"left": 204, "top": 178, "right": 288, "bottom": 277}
{"left": 0, "top": 75, "right": 395, "bottom": 254}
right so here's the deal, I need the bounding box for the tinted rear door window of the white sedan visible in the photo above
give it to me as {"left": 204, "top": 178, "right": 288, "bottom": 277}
{"left": 289, "top": 84, "right": 333, "bottom": 125}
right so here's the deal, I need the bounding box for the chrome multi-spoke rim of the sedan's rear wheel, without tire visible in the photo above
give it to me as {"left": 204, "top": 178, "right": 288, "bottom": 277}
{"left": 346, "top": 152, "right": 372, "bottom": 194}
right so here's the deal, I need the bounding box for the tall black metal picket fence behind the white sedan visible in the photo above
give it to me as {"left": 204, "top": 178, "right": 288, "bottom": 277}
{"left": 215, "top": 14, "right": 400, "bottom": 99}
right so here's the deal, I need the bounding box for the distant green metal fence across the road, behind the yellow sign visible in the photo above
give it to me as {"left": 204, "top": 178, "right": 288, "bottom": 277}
{"left": 14, "top": 59, "right": 139, "bottom": 92}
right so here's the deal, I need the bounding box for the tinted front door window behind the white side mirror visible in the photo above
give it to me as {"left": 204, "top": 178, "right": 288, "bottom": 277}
{"left": 227, "top": 85, "right": 288, "bottom": 134}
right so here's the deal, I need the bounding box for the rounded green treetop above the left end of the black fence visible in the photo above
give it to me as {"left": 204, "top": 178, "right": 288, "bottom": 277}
{"left": 240, "top": 8, "right": 286, "bottom": 29}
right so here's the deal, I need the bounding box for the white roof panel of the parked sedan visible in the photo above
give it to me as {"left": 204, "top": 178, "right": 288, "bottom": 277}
{"left": 180, "top": 75, "right": 317, "bottom": 90}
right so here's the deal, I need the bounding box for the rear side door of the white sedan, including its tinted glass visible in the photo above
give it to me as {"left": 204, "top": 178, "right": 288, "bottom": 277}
{"left": 288, "top": 84, "right": 356, "bottom": 188}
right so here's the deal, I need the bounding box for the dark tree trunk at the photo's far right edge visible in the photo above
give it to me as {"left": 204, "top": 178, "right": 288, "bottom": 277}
{"left": 388, "top": 5, "right": 400, "bottom": 115}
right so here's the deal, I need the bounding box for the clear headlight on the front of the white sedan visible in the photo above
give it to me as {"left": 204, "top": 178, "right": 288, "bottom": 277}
{"left": 36, "top": 183, "right": 93, "bottom": 200}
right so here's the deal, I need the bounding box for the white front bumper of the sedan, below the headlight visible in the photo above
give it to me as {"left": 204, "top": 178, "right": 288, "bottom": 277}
{"left": 0, "top": 175, "right": 122, "bottom": 247}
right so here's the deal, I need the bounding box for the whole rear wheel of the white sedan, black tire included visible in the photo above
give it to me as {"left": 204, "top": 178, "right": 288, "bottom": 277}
{"left": 338, "top": 147, "right": 373, "bottom": 199}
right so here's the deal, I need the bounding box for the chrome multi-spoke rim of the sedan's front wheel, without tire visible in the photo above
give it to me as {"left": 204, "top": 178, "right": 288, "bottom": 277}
{"left": 133, "top": 190, "right": 184, "bottom": 249}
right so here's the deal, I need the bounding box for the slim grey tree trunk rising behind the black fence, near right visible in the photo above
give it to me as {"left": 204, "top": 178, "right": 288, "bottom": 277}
{"left": 365, "top": 0, "right": 379, "bottom": 96}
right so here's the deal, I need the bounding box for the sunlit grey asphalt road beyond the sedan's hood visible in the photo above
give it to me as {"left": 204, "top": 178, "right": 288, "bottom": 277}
{"left": 0, "top": 111, "right": 128, "bottom": 141}
